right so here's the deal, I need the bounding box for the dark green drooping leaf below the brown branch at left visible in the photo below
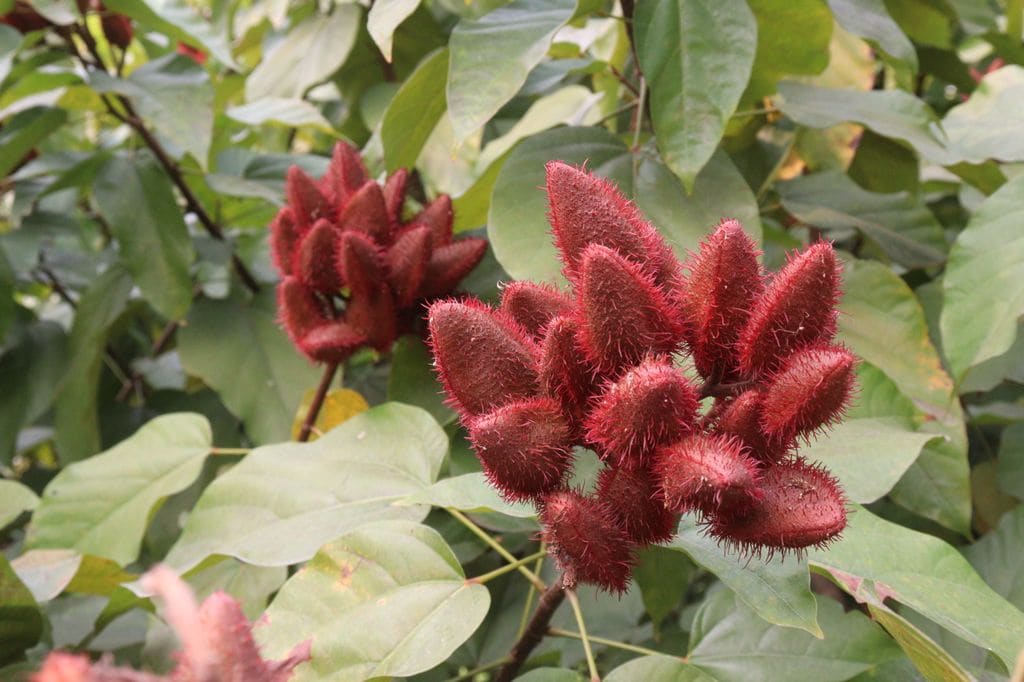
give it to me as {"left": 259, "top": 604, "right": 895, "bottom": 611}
{"left": 93, "top": 157, "right": 196, "bottom": 319}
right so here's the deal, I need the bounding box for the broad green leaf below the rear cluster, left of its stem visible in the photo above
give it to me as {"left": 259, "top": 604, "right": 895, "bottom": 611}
{"left": 178, "top": 290, "right": 321, "bottom": 443}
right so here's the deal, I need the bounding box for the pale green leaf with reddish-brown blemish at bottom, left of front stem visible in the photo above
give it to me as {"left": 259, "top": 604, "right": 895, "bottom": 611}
{"left": 254, "top": 520, "right": 490, "bottom": 682}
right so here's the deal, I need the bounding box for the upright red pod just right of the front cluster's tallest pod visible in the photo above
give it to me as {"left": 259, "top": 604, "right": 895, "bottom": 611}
{"left": 680, "top": 220, "right": 764, "bottom": 379}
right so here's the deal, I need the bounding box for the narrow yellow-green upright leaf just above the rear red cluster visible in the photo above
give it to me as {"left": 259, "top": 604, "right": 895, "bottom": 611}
{"left": 374, "top": 46, "right": 449, "bottom": 173}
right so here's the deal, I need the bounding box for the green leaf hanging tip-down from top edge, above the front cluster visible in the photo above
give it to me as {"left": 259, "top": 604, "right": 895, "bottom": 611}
{"left": 633, "top": 0, "right": 758, "bottom": 191}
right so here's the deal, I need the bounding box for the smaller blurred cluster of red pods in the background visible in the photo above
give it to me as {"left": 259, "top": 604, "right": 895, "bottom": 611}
{"left": 270, "top": 142, "right": 486, "bottom": 363}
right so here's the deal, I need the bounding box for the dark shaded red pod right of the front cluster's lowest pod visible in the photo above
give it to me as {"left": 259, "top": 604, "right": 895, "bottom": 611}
{"left": 595, "top": 467, "right": 679, "bottom": 545}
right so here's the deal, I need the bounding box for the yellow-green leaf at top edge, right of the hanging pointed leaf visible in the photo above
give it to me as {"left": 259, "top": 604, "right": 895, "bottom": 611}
{"left": 743, "top": 0, "right": 833, "bottom": 103}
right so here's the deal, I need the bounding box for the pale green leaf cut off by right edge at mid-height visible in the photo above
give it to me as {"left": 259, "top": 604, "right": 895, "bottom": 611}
{"left": 939, "top": 169, "right": 1024, "bottom": 381}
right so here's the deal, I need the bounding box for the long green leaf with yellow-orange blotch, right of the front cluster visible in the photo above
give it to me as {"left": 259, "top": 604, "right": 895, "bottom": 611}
{"left": 840, "top": 260, "right": 971, "bottom": 535}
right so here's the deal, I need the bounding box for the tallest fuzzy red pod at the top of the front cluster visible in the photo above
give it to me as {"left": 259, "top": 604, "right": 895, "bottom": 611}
{"left": 546, "top": 161, "right": 679, "bottom": 291}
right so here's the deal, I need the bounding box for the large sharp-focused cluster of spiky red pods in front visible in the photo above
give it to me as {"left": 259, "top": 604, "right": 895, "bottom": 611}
{"left": 429, "top": 162, "right": 855, "bottom": 591}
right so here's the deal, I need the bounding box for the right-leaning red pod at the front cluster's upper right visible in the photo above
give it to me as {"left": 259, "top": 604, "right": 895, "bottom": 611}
{"left": 736, "top": 242, "right": 840, "bottom": 377}
